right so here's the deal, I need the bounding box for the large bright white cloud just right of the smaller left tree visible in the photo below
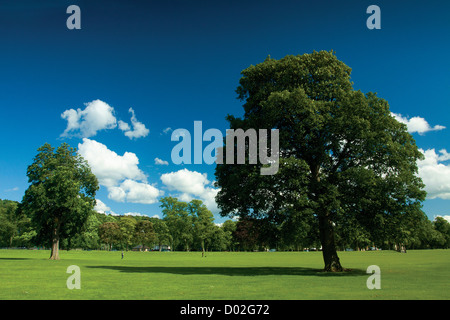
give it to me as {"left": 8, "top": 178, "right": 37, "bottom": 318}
{"left": 78, "top": 138, "right": 163, "bottom": 204}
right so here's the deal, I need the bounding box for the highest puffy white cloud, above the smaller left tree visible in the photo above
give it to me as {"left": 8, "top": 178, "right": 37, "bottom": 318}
{"left": 61, "top": 100, "right": 117, "bottom": 137}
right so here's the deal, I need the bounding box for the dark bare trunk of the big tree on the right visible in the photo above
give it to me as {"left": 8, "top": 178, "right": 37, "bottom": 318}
{"left": 319, "top": 216, "right": 343, "bottom": 272}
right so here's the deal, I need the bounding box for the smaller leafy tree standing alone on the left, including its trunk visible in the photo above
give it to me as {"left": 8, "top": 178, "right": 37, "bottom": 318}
{"left": 21, "top": 143, "right": 99, "bottom": 260}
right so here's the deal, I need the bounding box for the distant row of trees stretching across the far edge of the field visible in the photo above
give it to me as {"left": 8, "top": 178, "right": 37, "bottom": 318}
{"left": 0, "top": 197, "right": 450, "bottom": 251}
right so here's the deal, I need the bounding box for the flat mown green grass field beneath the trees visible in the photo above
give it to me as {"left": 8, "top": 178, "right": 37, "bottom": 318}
{"left": 0, "top": 250, "right": 450, "bottom": 300}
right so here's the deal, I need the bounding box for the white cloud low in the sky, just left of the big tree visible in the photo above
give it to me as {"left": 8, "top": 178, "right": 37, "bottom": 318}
{"left": 161, "top": 169, "right": 219, "bottom": 213}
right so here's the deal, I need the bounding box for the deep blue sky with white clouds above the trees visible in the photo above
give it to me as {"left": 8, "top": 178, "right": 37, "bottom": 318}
{"left": 0, "top": 0, "right": 450, "bottom": 222}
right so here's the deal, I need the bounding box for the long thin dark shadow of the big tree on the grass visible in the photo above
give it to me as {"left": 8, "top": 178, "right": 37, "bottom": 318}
{"left": 86, "top": 266, "right": 367, "bottom": 277}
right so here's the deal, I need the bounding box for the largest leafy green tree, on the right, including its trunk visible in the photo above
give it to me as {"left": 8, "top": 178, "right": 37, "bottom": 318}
{"left": 216, "top": 51, "right": 425, "bottom": 271}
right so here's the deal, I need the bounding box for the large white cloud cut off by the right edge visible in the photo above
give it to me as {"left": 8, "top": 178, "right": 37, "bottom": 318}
{"left": 417, "top": 149, "right": 450, "bottom": 199}
